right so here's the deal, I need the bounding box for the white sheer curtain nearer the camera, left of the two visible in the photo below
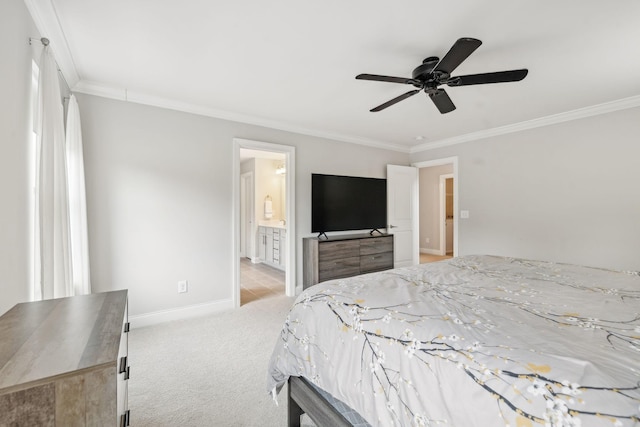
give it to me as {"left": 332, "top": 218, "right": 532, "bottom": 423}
{"left": 34, "top": 46, "right": 73, "bottom": 300}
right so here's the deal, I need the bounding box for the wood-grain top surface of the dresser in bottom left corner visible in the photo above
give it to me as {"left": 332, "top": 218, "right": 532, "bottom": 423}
{"left": 0, "top": 290, "right": 127, "bottom": 392}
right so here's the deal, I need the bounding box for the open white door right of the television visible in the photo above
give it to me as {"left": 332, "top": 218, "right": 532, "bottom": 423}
{"left": 387, "top": 165, "right": 419, "bottom": 267}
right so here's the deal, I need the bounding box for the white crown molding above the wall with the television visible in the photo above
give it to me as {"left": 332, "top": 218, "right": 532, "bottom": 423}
{"left": 73, "top": 80, "right": 409, "bottom": 153}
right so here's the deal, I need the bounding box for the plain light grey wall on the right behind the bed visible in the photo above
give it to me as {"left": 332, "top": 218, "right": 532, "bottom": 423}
{"left": 411, "top": 108, "right": 640, "bottom": 270}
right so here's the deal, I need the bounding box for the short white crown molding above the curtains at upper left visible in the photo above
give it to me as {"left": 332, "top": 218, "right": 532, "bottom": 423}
{"left": 24, "top": 0, "right": 80, "bottom": 90}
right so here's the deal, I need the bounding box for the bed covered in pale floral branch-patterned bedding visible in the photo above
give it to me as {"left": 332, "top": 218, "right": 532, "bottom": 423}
{"left": 267, "top": 256, "right": 640, "bottom": 427}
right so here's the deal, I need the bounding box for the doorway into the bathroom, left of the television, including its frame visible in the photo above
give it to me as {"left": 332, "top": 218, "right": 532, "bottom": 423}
{"left": 232, "top": 138, "right": 296, "bottom": 307}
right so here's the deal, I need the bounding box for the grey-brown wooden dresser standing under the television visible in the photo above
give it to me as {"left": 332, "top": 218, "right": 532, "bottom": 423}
{"left": 302, "top": 234, "right": 393, "bottom": 289}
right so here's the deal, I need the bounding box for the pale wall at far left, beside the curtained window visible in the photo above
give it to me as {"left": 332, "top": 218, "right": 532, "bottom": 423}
{"left": 0, "top": 0, "right": 39, "bottom": 315}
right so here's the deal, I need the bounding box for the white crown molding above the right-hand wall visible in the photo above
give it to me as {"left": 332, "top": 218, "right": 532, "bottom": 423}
{"left": 409, "top": 95, "right": 640, "bottom": 154}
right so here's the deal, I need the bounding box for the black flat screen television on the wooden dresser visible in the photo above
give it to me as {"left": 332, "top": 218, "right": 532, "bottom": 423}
{"left": 311, "top": 174, "right": 387, "bottom": 234}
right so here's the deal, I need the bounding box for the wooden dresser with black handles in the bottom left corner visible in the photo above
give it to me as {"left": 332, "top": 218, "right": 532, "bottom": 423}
{"left": 0, "top": 290, "right": 129, "bottom": 426}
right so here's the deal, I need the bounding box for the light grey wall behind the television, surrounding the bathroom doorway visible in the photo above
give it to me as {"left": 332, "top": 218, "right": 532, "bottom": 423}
{"left": 78, "top": 95, "right": 409, "bottom": 315}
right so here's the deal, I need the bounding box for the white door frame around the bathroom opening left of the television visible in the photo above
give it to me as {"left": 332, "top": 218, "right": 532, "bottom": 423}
{"left": 232, "top": 138, "right": 296, "bottom": 308}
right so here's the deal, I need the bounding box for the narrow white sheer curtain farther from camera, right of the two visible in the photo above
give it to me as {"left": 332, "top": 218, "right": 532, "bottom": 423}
{"left": 66, "top": 95, "right": 91, "bottom": 295}
